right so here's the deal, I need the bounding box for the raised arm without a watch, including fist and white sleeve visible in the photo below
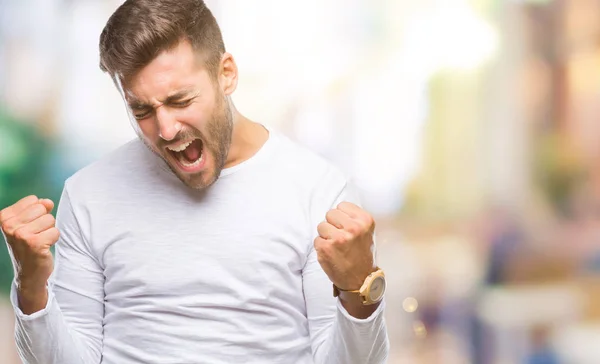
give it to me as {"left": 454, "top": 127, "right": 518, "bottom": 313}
{"left": 0, "top": 188, "right": 104, "bottom": 364}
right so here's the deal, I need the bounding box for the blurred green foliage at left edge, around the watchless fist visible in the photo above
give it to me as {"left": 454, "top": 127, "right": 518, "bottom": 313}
{"left": 0, "top": 108, "right": 61, "bottom": 294}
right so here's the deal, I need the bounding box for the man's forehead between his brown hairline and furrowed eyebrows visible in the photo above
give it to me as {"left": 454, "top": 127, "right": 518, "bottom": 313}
{"left": 123, "top": 42, "right": 211, "bottom": 101}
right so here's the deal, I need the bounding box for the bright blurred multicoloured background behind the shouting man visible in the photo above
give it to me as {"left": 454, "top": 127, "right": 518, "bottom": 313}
{"left": 0, "top": 0, "right": 600, "bottom": 364}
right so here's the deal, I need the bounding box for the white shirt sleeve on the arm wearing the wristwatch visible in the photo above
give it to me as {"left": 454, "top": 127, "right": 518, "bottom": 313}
{"left": 302, "top": 168, "right": 389, "bottom": 364}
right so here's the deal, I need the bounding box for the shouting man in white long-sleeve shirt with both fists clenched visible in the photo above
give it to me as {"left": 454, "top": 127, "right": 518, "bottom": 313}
{"left": 0, "top": 0, "right": 389, "bottom": 364}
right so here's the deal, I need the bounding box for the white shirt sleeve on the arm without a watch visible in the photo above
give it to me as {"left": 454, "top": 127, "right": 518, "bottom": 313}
{"left": 10, "top": 187, "right": 104, "bottom": 364}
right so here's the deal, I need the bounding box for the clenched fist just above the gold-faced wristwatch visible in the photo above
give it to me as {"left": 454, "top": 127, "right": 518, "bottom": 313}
{"left": 315, "top": 202, "right": 375, "bottom": 290}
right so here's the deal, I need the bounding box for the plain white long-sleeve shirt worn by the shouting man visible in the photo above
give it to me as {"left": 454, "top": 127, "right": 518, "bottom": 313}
{"left": 11, "top": 130, "right": 389, "bottom": 364}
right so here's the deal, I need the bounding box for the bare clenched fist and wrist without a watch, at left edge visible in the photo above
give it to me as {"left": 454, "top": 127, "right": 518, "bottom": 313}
{"left": 0, "top": 196, "right": 59, "bottom": 312}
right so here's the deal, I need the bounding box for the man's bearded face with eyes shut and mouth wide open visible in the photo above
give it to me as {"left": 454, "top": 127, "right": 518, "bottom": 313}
{"left": 123, "top": 42, "right": 233, "bottom": 189}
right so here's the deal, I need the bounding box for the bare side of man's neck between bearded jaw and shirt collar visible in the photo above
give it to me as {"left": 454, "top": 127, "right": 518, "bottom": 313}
{"left": 225, "top": 109, "right": 269, "bottom": 168}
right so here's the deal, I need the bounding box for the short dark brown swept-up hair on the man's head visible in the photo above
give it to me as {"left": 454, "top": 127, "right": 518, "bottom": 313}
{"left": 100, "top": 0, "right": 225, "bottom": 81}
